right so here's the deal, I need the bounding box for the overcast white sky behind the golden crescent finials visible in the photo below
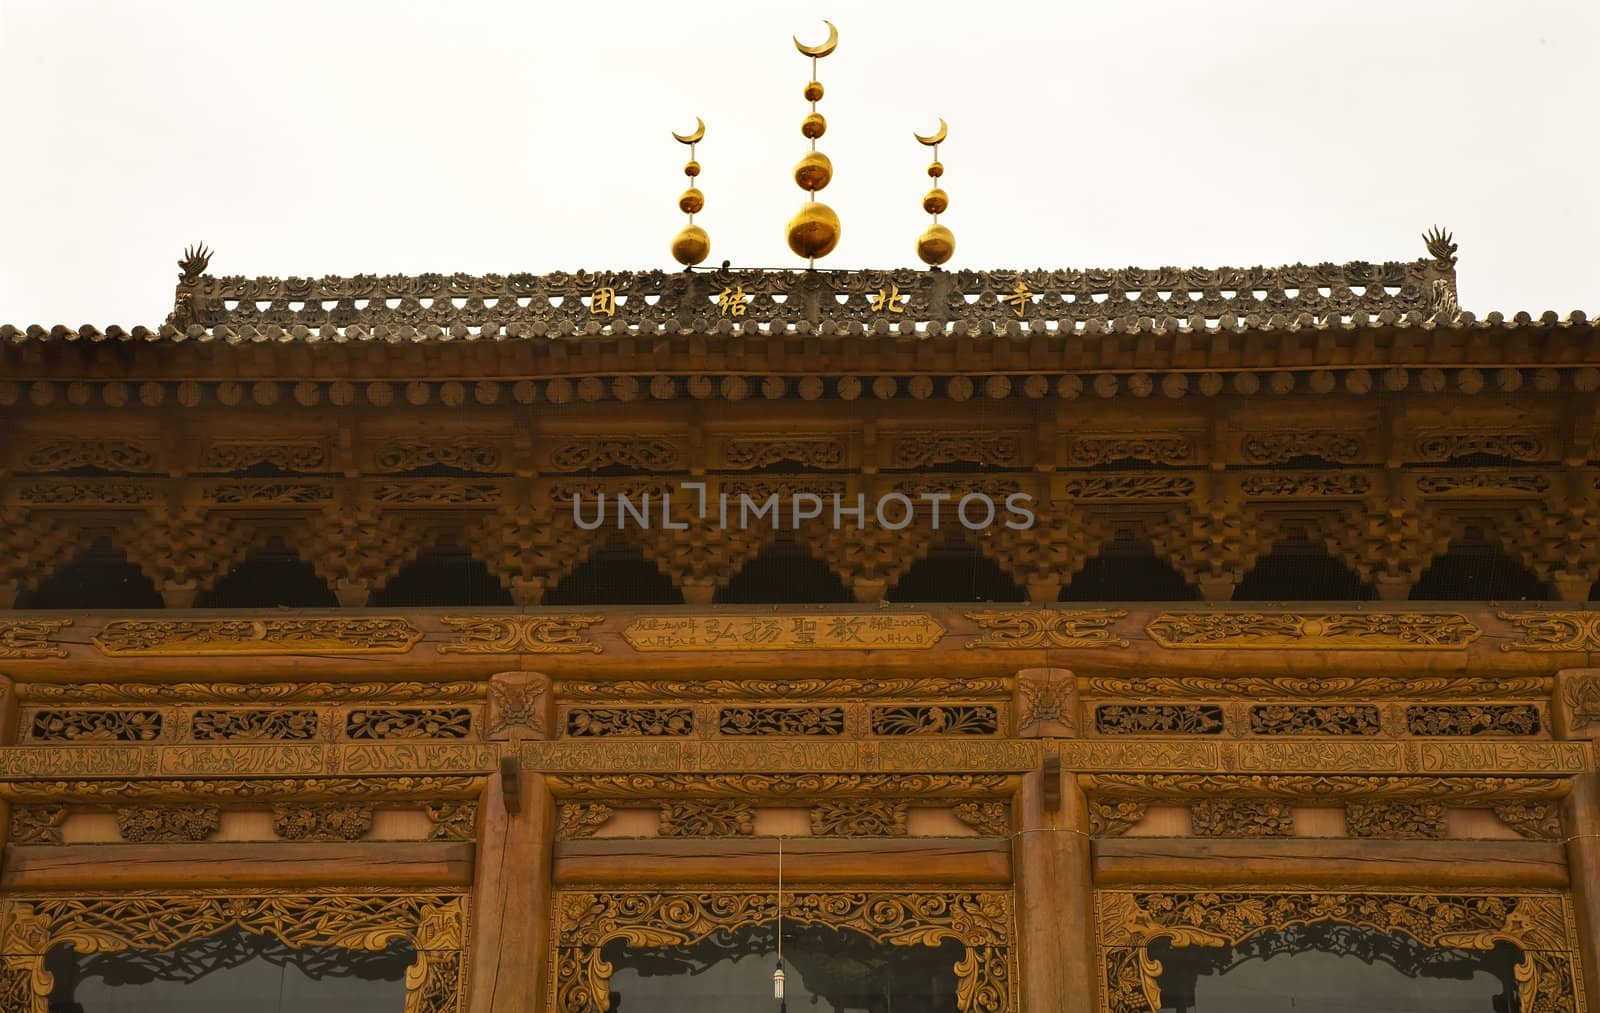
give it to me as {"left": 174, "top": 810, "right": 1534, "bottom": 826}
{"left": 0, "top": 0, "right": 1600, "bottom": 326}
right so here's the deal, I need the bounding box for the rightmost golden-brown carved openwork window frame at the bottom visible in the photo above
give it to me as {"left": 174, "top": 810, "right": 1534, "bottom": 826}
{"left": 1094, "top": 888, "right": 1587, "bottom": 1013}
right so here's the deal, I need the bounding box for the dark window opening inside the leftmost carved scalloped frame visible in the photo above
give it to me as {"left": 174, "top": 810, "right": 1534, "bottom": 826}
{"left": 45, "top": 930, "right": 416, "bottom": 1013}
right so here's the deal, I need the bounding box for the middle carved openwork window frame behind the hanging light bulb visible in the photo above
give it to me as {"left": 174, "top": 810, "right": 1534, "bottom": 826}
{"left": 549, "top": 890, "right": 1019, "bottom": 1013}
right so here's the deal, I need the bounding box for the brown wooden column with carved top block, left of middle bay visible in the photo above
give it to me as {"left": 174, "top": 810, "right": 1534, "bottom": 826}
{"left": 467, "top": 672, "right": 555, "bottom": 1013}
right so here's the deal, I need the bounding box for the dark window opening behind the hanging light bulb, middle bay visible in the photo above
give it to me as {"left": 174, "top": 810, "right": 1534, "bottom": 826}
{"left": 602, "top": 923, "right": 966, "bottom": 1013}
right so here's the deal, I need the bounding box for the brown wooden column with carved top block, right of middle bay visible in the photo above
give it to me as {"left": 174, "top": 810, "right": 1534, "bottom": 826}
{"left": 1013, "top": 669, "right": 1099, "bottom": 1013}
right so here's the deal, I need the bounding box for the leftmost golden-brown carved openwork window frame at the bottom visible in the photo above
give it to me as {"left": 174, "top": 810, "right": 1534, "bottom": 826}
{"left": 0, "top": 890, "right": 469, "bottom": 1013}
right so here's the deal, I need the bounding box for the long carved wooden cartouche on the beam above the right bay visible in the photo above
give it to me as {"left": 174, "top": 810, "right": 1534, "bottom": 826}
{"left": 1146, "top": 611, "right": 1483, "bottom": 651}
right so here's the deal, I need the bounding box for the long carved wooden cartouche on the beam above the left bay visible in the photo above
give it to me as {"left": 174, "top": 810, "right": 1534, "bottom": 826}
{"left": 91, "top": 616, "right": 422, "bottom": 658}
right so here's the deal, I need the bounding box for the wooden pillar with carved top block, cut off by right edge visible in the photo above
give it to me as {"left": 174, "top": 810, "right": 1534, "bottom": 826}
{"left": 1555, "top": 669, "right": 1600, "bottom": 1010}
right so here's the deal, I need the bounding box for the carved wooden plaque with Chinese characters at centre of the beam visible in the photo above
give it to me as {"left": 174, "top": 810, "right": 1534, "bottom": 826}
{"left": 622, "top": 613, "right": 946, "bottom": 651}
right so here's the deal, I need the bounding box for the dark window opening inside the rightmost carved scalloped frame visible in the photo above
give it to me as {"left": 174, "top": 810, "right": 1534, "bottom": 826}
{"left": 1149, "top": 922, "right": 1522, "bottom": 1013}
